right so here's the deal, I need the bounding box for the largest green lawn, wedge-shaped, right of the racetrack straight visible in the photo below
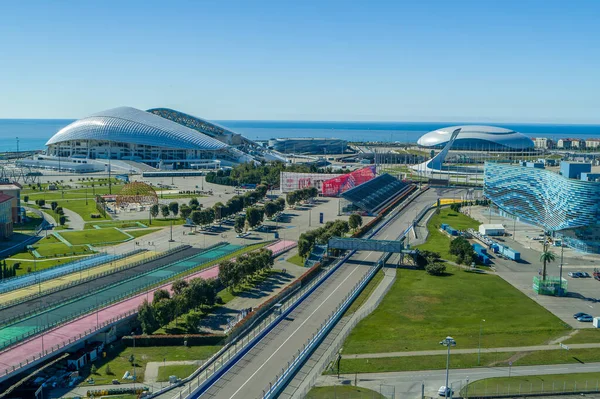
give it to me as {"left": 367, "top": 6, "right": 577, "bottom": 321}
{"left": 344, "top": 267, "right": 570, "bottom": 353}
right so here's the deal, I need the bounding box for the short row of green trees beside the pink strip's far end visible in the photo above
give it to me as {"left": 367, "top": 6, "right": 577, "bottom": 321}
{"left": 219, "top": 248, "right": 273, "bottom": 291}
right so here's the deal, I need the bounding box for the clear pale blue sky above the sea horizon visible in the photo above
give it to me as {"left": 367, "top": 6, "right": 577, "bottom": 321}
{"left": 0, "top": 0, "right": 600, "bottom": 123}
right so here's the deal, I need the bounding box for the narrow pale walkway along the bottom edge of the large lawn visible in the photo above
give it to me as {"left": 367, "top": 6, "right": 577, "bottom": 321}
{"left": 344, "top": 343, "right": 600, "bottom": 359}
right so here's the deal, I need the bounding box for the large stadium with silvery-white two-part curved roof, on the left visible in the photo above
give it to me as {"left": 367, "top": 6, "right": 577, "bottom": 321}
{"left": 45, "top": 107, "right": 284, "bottom": 169}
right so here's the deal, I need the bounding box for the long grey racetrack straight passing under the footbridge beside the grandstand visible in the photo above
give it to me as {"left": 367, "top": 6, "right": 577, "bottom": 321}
{"left": 176, "top": 189, "right": 466, "bottom": 398}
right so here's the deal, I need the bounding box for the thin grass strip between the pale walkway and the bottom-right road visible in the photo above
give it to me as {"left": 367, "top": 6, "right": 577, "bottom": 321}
{"left": 327, "top": 345, "right": 600, "bottom": 374}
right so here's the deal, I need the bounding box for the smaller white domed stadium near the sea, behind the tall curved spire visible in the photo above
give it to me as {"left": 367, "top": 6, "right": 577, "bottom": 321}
{"left": 417, "top": 125, "right": 534, "bottom": 151}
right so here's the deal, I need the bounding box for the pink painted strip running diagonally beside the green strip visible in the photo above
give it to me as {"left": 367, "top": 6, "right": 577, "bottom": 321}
{"left": 0, "top": 241, "right": 296, "bottom": 376}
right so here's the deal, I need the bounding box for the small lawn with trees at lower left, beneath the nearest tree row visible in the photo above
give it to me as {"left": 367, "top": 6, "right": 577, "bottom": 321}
{"left": 80, "top": 344, "right": 221, "bottom": 386}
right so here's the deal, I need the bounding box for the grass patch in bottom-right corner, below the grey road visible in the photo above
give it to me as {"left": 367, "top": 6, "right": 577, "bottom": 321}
{"left": 460, "top": 373, "right": 600, "bottom": 396}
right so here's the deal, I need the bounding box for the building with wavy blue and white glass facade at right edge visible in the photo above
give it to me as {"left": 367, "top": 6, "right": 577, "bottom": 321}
{"left": 484, "top": 162, "right": 600, "bottom": 253}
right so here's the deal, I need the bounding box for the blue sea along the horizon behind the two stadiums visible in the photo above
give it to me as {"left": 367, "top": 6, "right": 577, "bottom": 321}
{"left": 0, "top": 119, "right": 600, "bottom": 152}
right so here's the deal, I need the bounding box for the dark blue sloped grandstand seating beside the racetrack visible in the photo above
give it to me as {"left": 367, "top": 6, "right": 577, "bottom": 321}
{"left": 342, "top": 173, "right": 409, "bottom": 213}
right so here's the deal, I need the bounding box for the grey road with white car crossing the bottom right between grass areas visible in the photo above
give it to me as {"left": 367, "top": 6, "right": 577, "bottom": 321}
{"left": 317, "top": 363, "right": 600, "bottom": 399}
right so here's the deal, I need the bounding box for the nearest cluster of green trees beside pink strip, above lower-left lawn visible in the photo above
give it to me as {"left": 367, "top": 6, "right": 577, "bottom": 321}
{"left": 138, "top": 278, "right": 218, "bottom": 334}
